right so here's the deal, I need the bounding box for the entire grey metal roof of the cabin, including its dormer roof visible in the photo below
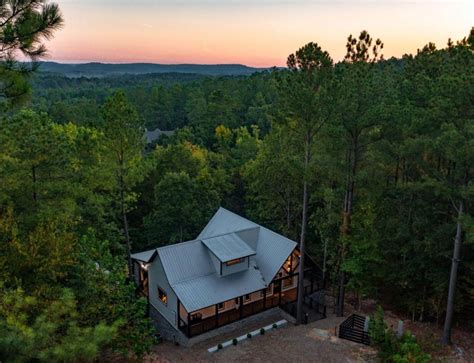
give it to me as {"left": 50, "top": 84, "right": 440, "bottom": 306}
{"left": 132, "top": 208, "right": 296, "bottom": 312}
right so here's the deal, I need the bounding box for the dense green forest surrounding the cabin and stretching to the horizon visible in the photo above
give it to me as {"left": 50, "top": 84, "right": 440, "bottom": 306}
{"left": 0, "top": 0, "right": 474, "bottom": 361}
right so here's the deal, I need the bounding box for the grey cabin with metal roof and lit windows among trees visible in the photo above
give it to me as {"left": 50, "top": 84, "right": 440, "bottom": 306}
{"left": 132, "top": 208, "right": 323, "bottom": 344}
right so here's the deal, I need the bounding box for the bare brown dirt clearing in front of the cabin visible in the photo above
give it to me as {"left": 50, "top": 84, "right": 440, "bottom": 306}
{"left": 146, "top": 316, "right": 374, "bottom": 363}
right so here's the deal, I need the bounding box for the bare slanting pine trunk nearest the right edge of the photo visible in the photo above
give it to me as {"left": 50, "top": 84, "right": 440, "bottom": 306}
{"left": 441, "top": 200, "right": 464, "bottom": 345}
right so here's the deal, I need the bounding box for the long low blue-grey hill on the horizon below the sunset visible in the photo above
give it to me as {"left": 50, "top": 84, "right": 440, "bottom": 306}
{"left": 39, "top": 62, "right": 268, "bottom": 77}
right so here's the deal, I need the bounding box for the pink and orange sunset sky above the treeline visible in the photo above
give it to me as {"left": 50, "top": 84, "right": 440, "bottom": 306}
{"left": 48, "top": 0, "right": 474, "bottom": 67}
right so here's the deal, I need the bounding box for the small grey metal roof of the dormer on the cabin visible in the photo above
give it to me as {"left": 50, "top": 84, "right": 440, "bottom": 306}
{"left": 202, "top": 233, "right": 256, "bottom": 262}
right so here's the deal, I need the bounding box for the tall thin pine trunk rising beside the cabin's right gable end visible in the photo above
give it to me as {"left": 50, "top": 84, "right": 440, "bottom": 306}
{"left": 296, "top": 135, "right": 311, "bottom": 324}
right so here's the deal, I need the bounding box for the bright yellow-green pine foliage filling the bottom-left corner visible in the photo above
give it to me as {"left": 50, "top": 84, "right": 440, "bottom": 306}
{"left": 0, "top": 287, "right": 119, "bottom": 362}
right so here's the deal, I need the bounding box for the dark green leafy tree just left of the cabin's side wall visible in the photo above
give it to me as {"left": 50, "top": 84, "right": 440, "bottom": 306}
{"left": 71, "top": 230, "right": 156, "bottom": 357}
